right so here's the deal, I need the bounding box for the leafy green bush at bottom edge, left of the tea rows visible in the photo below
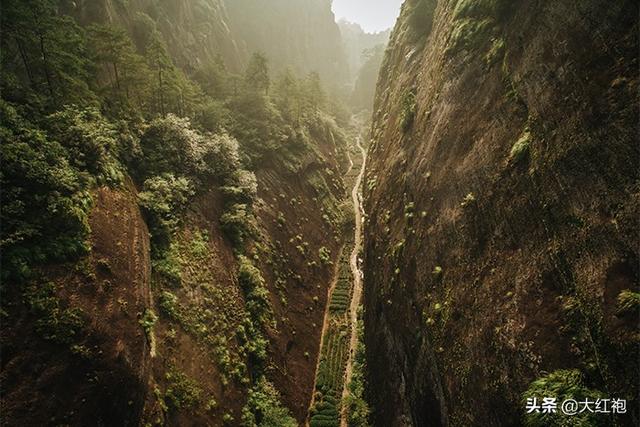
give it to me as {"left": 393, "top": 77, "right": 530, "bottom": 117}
{"left": 242, "top": 376, "right": 298, "bottom": 427}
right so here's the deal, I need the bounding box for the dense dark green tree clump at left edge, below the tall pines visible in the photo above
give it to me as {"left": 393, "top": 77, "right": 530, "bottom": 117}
{"left": 0, "top": 101, "right": 92, "bottom": 279}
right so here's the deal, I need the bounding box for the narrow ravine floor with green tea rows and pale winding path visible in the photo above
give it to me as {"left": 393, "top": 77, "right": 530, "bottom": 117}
{"left": 306, "top": 137, "right": 366, "bottom": 427}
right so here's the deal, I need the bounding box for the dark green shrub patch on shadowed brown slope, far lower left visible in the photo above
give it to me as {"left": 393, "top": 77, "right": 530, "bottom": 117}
{"left": 24, "top": 282, "right": 85, "bottom": 345}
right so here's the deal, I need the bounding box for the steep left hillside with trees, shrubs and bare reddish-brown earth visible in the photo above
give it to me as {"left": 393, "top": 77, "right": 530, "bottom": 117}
{"left": 0, "top": 0, "right": 351, "bottom": 426}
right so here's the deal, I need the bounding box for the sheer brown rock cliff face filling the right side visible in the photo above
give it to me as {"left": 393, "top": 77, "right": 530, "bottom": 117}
{"left": 364, "top": 0, "right": 640, "bottom": 426}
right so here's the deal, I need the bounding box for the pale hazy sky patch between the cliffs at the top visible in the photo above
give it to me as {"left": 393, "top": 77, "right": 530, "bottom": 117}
{"left": 333, "top": 0, "right": 403, "bottom": 33}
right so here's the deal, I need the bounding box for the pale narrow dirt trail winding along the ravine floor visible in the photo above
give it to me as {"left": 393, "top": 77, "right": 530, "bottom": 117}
{"left": 340, "top": 137, "right": 367, "bottom": 427}
